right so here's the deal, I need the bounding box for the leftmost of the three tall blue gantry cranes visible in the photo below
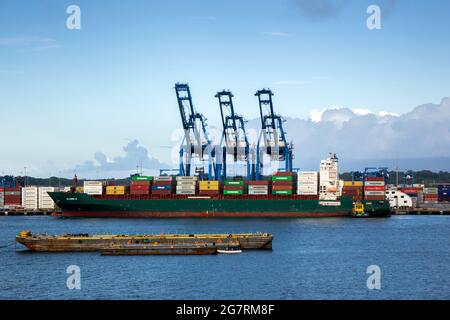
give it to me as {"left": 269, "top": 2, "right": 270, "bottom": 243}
{"left": 175, "top": 83, "right": 215, "bottom": 180}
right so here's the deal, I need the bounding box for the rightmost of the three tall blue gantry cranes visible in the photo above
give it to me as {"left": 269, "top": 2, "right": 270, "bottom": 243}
{"left": 255, "top": 89, "right": 293, "bottom": 179}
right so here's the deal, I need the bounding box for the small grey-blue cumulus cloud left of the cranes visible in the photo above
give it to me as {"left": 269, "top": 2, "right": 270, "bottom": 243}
{"left": 72, "top": 140, "right": 171, "bottom": 177}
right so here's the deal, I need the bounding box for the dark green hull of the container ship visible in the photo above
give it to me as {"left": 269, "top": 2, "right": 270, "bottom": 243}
{"left": 49, "top": 192, "right": 389, "bottom": 218}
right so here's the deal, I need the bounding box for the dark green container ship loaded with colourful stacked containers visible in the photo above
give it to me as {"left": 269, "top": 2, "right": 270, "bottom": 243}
{"left": 48, "top": 155, "right": 390, "bottom": 218}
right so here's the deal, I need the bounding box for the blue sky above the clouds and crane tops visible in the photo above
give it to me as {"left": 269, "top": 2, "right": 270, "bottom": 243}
{"left": 0, "top": 0, "right": 450, "bottom": 176}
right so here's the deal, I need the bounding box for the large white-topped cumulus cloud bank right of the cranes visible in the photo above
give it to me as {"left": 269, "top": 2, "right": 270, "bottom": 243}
{"left": 249, "top": 98, "right": 450, "bottom": 170}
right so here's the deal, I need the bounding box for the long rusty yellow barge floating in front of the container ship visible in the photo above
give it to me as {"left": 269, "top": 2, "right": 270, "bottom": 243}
{"left": 16, "top": 231, "right": 273, "bottom": 252}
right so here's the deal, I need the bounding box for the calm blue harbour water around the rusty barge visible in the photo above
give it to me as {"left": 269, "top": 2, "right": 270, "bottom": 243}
{"left": 0, "top": 216, "right": 450, "bottom": 299}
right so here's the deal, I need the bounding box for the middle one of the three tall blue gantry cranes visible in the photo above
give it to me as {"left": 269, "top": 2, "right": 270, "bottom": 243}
{"left": 215, "top": 90, "right": 255, "bottom": 179}
